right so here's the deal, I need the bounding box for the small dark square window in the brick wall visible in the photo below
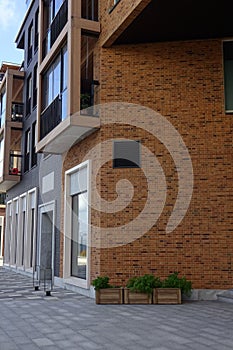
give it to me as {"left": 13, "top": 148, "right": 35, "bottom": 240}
{"left": 113, "top": 140, "right": 141, "bottom": 168}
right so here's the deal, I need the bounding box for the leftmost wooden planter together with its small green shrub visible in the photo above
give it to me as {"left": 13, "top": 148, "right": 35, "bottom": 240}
{"left": 92, "top": 276, "right": 123, "bottom": 304}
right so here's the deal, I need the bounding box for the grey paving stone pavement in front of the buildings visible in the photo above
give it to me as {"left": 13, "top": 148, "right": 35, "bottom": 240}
{"left": 0, "top": 268, "right": 233, "bottom": 350}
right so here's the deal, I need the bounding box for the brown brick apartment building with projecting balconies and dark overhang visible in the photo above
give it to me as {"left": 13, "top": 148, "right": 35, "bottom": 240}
{"left": 2, "top": 0, "right": 233, "bottom": 296}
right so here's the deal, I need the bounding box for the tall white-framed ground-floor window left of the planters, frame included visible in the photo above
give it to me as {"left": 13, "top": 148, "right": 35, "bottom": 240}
{"left": 64, "top": 161, "right": 89, "bottom": 288}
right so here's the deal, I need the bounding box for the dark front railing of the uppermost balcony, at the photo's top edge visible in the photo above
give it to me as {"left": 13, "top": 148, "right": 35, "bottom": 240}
{"left": 42, "top": 0, "right": 68, "bottom": 59}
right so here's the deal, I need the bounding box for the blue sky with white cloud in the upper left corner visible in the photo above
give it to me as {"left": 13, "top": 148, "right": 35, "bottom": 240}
{"left": 0, "top": 0, "right": 27, "bottom": 65}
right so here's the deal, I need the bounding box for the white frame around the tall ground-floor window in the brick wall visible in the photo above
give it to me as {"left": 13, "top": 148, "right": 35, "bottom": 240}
{"left": 63, "top": 160, "right": 91, "bottom": 289}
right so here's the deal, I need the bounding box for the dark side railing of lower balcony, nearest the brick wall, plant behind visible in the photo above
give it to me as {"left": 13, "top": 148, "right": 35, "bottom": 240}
{"left": 80, "top": 79, "right": 99, "bottom": 116}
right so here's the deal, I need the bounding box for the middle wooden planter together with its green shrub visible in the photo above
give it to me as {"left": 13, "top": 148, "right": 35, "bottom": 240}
{"left": 124, "top": 275, "right": 161, "bottom": 304}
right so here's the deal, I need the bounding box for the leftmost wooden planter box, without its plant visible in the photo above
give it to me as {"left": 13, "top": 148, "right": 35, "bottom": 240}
{"left": 95, "top": 288, "right": 124, "bottom": 304}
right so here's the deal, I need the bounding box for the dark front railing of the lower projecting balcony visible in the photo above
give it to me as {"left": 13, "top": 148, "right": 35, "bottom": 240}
{"left": 40, "top": 95, "right": 62, "bottom": 139}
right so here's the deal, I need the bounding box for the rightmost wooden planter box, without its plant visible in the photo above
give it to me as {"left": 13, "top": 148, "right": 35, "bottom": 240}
{"left": 153, "top": 288, "right": 181, "bottom": 304}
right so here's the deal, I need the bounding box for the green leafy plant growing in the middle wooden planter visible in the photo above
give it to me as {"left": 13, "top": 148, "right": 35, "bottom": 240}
{"left": 126, "top": 275, "right": 161, "bottom": 294}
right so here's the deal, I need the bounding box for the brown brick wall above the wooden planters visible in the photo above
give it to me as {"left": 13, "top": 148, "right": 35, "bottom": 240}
{"left": 61, "top": 40, "right": 233, "bottom": 288}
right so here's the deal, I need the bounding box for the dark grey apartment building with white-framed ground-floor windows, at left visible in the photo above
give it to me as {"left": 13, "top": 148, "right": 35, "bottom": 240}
{"left": 3, "top": 1, "right": 62, "bottom": 278}
